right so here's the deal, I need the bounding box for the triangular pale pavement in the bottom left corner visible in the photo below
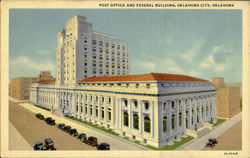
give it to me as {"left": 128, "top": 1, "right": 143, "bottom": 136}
{"left": 9, "top": 122, "right": 33, "bottom": 150}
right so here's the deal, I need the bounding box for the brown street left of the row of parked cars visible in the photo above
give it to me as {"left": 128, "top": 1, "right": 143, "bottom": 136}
{"left": 9, "top": 102, "right": 96, "bottom": 150}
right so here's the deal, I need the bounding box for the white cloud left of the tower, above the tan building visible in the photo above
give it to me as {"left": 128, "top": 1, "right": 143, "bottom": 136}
{"left": 10, "top": 56, "right": 56, "bottom": 71}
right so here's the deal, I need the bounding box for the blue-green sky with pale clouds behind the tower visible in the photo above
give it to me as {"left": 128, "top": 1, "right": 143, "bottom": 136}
{"left": 9, "top": 9, "right": 242, "bottom": 82}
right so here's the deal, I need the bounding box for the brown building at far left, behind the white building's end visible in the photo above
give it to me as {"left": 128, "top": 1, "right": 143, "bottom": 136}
{"left": 9, "top": 71, "right": 53, "bottom": 100}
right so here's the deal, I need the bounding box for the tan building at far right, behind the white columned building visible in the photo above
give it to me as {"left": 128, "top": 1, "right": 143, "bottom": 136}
{"left": 212, "top": 77, "right": 240, "bottom": 118}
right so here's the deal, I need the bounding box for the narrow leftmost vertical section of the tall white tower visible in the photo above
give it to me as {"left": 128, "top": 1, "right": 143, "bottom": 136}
{"left": 56, "top": 30, "right": 65, "bottom": 84}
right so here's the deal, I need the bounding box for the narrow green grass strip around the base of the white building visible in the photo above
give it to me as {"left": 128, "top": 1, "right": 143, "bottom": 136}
{"left": 65, "top": 116, "right": 194, "bottom": 150}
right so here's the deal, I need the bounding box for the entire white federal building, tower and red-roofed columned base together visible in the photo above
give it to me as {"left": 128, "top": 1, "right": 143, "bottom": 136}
{"left": 30, "top": 16, "right": 216, "bottom": 147}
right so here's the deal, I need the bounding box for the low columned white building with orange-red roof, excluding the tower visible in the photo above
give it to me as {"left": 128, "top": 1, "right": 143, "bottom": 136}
{"left": 30, "top": 73, "right": 216, "bottom": 147}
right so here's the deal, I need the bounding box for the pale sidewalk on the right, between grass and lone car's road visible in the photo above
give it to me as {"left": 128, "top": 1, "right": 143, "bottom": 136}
{"left": 177, "top": 113, "right": 242, "bottom": 150}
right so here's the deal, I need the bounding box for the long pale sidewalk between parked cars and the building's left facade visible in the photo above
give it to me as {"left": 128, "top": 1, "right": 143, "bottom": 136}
{"left": 19, "top": 103, "right": 148, "bottom": 150}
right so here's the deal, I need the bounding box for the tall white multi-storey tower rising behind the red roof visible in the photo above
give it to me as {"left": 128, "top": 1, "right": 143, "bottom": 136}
{"left": 56, "top": 16, "right": 130, "bottom": 85}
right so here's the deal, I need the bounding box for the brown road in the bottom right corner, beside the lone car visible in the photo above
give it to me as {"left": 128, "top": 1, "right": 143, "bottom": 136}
{"left": 203, "top": 121, "right": 242, "bottom": 150}
